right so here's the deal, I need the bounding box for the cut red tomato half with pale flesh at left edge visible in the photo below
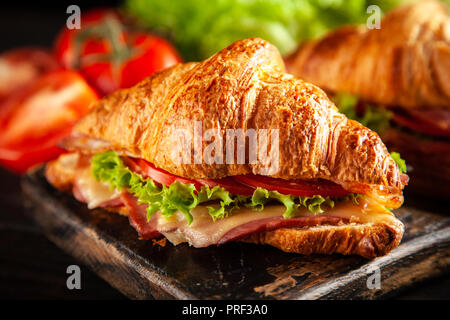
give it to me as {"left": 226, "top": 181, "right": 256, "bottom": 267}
{"left": 0, "top": 70, "right": 98, "bottom": 173}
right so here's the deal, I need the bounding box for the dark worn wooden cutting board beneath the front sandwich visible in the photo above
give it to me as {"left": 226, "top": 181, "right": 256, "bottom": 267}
{"left": 22, "top": 169, "right": 450, "bottom": 299}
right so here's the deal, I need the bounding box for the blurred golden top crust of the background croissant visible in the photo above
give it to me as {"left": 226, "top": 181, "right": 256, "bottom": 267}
{"left": 286, "top": 1, "right": 450, "bottom": 109}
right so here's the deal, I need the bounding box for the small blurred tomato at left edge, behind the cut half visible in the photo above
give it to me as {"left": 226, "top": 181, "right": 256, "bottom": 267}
{"left": 0, "top": 47, "right": 60, "bottom": 103}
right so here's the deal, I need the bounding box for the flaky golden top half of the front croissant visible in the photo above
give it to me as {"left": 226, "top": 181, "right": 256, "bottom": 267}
{"left": 71, "top": 38, "right": 403, "bottom": 207}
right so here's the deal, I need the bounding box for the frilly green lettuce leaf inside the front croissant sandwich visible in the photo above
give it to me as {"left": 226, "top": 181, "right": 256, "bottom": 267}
{"left": 91, "top": 151, "right": 356, "bottom": 224}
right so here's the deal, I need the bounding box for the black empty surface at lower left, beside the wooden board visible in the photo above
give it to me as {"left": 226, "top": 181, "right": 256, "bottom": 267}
{"left": 0, "top": 168, "right": 126, "bottom": 300}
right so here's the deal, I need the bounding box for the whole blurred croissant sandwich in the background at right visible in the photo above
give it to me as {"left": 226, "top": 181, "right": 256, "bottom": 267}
{"left": 286, "top": 1, "right": 450, "bottom": 199}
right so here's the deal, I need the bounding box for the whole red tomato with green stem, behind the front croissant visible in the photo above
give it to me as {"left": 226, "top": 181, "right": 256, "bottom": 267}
{"left": 55, "top": 9, "right": 181, "bottom": 95}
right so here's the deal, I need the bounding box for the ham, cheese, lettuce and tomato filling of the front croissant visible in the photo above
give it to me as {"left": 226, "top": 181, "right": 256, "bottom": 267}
{"left": 47, "top": 151, "right": 397, "bottom": 247}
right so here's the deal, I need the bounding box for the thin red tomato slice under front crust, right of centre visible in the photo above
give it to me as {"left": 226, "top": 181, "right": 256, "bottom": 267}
{"left": 233, "top": 174, "right": 349, "bottom": 197}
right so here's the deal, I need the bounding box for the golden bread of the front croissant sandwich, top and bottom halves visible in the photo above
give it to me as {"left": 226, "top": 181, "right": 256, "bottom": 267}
{"left": 46, "top": 38, "right": 407, "bottom": 257}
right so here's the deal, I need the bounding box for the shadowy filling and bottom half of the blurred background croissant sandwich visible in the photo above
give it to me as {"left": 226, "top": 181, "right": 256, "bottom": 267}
{"left": 331, "top": 93, "right": 450, "bottom": 197}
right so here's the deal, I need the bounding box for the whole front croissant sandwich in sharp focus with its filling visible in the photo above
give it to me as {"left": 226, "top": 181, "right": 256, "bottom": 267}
{"left": 46, "top": 39, "right": 408, "bottom": 258}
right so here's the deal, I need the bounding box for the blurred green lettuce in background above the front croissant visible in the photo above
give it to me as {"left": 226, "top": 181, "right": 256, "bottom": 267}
{"left": 125, "top": 0, "right": 404, "bottom": 60}
